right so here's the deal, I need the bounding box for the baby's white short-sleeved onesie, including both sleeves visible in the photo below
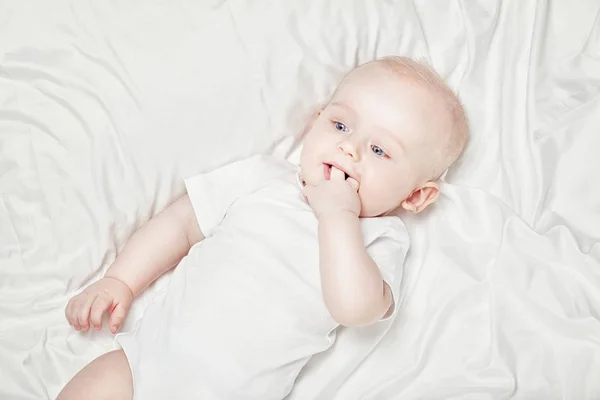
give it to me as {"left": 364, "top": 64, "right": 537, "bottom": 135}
{"left": 116, "top": 156, "right": 409, "bottom": 400}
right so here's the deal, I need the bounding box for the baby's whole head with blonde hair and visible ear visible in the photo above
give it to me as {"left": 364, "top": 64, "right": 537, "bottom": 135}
{"left": 300, "top": 57, "right": 468, "bottom": 217}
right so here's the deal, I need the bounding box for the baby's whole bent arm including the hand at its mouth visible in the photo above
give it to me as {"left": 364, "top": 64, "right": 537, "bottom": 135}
{"left": 304, "top": 167, "right": 392, "bottom": 326}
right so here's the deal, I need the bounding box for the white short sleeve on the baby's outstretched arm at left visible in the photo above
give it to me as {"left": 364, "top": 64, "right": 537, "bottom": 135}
{"left": 185, "top": 156, "right": 270, "bottom": 237}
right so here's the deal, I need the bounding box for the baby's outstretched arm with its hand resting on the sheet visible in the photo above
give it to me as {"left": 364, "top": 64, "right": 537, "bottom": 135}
{"left": 65, "top": 195, "right": 204, "bottom": 333}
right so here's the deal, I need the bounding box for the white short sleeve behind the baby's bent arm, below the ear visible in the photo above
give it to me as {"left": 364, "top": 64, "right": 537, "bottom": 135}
{"left": 367, "top": 216, "right": 410, "bottom": 321}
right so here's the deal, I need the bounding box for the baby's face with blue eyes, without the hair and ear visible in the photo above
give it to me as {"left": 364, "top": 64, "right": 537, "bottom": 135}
{"left": 300, "top": 64, "right": 436, "bottom": 217}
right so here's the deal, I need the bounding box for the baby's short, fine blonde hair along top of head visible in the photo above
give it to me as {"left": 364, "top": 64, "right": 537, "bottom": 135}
{"left": 371, "top": 56, "right": 469, "bottom": 179}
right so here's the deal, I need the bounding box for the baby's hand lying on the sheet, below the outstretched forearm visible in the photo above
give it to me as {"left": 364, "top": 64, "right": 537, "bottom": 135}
{"left": 65, "top": 278, "right": 133, "bottom": 333}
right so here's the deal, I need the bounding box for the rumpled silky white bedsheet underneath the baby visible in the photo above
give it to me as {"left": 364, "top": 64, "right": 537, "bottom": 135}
{"left": 0, "top": 0, "right": 600, "bottom": 400}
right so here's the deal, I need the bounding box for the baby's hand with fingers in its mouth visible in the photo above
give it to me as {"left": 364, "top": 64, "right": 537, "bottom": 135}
{"left": 304, "top": 166, "right": 361, "bottom": 219}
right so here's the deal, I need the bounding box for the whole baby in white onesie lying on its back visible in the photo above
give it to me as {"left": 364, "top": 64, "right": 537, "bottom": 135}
{"left": 58, "top": 57, "right": 468, "bottom": 400}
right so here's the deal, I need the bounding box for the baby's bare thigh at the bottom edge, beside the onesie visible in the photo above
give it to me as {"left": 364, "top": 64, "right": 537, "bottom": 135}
{"left": 57, "top": 350, "right": 133, "bottom": 400}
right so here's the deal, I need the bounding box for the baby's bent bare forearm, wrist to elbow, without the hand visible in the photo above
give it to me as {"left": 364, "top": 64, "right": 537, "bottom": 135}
{"left": 319, "top": 211, "right": 392, "bottom": 326}
